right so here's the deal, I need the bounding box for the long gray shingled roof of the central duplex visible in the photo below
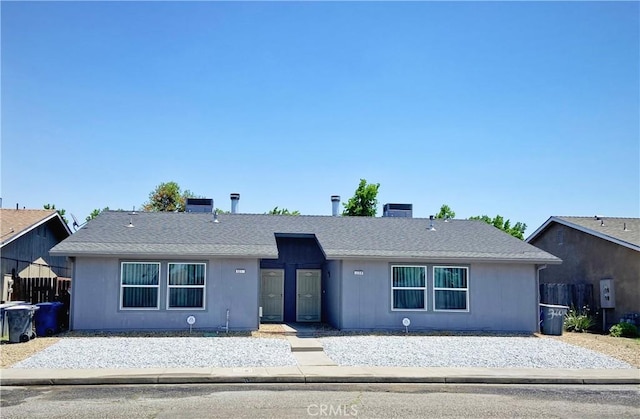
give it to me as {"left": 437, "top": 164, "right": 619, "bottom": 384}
{"left": 51, "top": 211, "right": 560, "bottom": 263}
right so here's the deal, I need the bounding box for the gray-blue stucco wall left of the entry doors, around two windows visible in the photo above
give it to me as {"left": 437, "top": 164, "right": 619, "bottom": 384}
{"left": 71, "top": 258, "right": 259, "bottom": 330}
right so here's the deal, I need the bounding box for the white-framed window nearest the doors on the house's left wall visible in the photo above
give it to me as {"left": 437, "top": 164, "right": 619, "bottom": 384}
{"left": 167, "top": 263, "right": 205, "bottom": 308}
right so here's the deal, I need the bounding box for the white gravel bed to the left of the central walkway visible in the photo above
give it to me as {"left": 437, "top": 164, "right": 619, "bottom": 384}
{"left": 12, "top": 337, "right": 297, "bottom": 369}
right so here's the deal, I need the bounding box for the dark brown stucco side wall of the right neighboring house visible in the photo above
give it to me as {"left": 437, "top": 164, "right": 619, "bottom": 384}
{"left": 531, "top": 223, "right": 640, "bottom": 329}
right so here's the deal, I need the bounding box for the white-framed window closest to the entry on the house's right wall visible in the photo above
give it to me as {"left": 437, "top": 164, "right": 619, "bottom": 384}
{"left": 391, "top": 266, "right": 427, "bottom": 310}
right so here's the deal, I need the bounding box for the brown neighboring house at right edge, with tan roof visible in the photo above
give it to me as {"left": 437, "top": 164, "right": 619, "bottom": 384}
{"left": 526, "top": 216, "right": 640, "bottom": 329}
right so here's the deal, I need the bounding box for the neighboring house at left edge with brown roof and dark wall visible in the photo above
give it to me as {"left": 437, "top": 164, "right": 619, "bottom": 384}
{"left": 0, "top": 208, "right": 71, "bottom": 299}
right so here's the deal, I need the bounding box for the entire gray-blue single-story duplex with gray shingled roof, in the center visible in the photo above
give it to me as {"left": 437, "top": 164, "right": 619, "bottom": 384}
{"left": 51, "top": 202, "right": 560, "bottom": 332}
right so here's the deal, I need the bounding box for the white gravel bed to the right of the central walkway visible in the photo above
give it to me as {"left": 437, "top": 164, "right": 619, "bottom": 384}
{"left": 320, "top": 336, "right": 634, "bottom": 369}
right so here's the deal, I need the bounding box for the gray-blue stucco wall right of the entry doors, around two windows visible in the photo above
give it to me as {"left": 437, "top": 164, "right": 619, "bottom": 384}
{"left": 341, "top": 261, "right": 539, "bottom": 333}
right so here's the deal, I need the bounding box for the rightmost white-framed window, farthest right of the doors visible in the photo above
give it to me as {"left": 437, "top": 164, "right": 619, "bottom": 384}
{"left": 433, "top": 266, "right": 469, "bottom": 311}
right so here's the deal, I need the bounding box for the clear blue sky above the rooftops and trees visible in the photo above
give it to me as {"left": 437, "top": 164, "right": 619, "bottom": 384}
{"left": 1, "top": 1, "right": 640, "bottom": 234}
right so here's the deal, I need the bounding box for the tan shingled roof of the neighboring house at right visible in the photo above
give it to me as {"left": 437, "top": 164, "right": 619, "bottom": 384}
{"left": 527, "top": 216, "right": 640, "bottom": 251}
